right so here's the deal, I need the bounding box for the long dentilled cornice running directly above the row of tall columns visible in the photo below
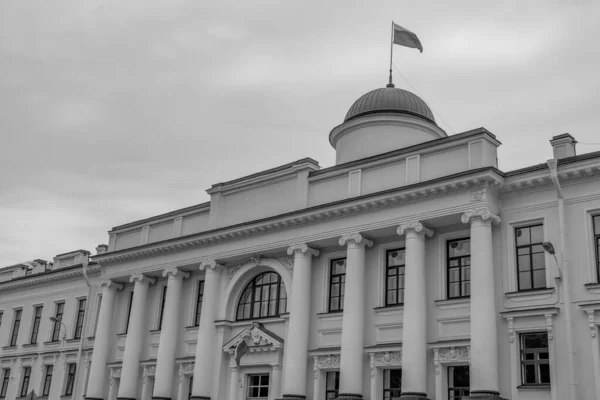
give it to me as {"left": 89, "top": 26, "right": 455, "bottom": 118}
{"left": 93, "top": 167, "right": 503, "bottom": 265}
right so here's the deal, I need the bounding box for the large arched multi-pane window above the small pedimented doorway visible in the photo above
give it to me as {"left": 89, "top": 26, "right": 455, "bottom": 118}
{"left": 236, "top": 272, "right": 287, "bottom": 321}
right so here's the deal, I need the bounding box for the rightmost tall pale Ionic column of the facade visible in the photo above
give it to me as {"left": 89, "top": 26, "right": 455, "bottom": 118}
{"left": 461, "top": 208, "right": 500, "bottom": 399}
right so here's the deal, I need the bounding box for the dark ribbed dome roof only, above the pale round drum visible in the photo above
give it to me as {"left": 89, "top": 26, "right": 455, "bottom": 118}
{"left": 344, "top": 84, "right": 435, "bottom": 124}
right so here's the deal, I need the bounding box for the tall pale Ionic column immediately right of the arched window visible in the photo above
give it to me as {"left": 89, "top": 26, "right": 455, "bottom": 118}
{"left": 283, "top": 243, "right": 319, "bottom": 400}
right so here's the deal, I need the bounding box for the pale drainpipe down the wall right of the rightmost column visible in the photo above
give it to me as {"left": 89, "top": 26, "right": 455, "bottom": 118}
{"left": 547, "top": 159, "right": 577, "bottom": 400}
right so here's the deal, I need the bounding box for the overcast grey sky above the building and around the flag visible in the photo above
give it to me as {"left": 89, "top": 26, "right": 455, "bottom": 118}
{"left": 0, "top": 0, "right": 600, "bottom": 266}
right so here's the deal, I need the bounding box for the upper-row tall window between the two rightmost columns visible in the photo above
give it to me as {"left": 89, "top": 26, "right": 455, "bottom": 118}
{"left": 446, "top": 239, "right": 471, "bottom": 299}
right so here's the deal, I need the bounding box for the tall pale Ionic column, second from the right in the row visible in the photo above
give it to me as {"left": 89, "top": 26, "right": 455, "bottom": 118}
{"left": 397, "top": 221, "right": 433, "bottom": 400}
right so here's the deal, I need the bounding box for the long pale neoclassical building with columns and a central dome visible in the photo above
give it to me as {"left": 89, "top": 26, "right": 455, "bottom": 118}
{"left": 0, "top": 84, "right": 600, "bottom": 400}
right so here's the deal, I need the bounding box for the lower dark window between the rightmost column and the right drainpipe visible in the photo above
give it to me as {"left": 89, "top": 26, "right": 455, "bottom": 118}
{"left": 521, "top": 333, "right": 550, "bottom": 385}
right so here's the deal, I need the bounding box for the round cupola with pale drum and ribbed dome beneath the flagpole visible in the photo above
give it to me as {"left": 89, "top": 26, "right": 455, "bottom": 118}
{"left": 329, "top": 83, "right": 447, "bottom": 164}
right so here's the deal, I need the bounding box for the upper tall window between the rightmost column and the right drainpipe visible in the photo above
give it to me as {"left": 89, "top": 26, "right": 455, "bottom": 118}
{"left": 515, "top": 224, "right": 546, "bottom": 291}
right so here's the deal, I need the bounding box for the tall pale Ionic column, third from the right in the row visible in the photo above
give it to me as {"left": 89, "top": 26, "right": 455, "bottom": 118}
{"left": 338, "top": 233, "right": 373, "bottom": 400}
